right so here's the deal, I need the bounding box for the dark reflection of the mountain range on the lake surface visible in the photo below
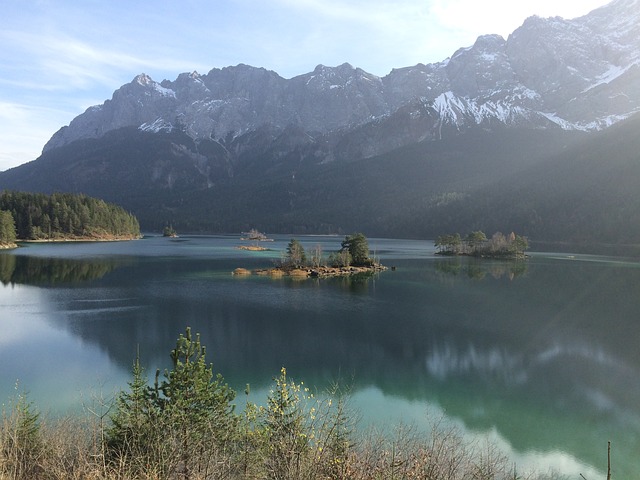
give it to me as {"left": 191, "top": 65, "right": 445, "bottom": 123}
{"left": 0, "top": 242, "right": 640, "bottom": 478}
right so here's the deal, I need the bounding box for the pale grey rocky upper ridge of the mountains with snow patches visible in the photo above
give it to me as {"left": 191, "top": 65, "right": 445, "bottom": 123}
{"left": 45, "top": 0, "right": 640, "bottom": 153}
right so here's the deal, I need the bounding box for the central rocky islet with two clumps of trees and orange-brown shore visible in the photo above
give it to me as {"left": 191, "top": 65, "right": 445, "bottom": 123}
{"left": 233, "top": 233, "right": 387, "bottom": 278}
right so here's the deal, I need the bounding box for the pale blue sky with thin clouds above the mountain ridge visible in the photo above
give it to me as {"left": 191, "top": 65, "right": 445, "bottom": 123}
{"left": 0, "top": 0, "right": 608, "bottom": 170}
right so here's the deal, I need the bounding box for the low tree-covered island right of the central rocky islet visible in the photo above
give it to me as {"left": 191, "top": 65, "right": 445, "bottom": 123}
{"left": 435, "top": 230, "right": 529, "bottom": 258}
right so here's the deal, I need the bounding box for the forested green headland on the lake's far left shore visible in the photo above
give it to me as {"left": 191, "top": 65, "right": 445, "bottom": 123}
{"left": 0, "top": 191, "right": 140, "bottom": 242}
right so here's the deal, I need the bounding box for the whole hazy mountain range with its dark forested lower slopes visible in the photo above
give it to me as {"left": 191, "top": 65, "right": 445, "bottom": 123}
{"left": 0, "top": 0, "right": 640, "bottom": 243}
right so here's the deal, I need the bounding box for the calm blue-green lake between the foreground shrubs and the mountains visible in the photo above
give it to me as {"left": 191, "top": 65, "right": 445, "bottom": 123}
{"left": 0, "top": 236, "right": 640, "bottom": 480}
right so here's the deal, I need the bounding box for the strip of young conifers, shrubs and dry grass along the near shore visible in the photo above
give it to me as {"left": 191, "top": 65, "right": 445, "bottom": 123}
{"left": 0, "top": 329, "right": 568, "bottom": 480}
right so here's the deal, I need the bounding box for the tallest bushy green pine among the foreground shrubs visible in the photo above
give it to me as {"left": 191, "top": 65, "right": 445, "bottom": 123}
{"left": 107, "top": 328, "right": 238, "bottom": 480}
